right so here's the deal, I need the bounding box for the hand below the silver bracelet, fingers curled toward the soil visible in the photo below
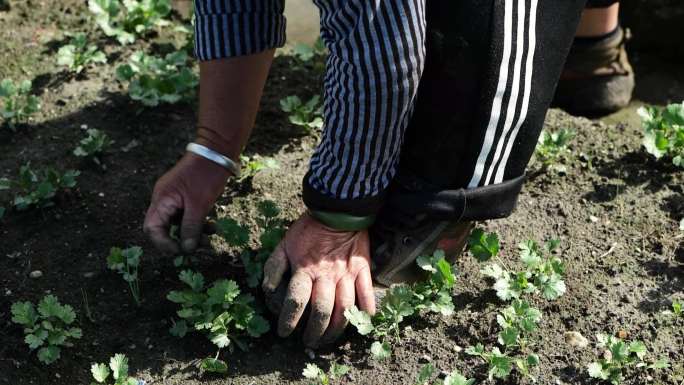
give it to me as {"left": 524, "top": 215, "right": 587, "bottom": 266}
{"left": 143, "top": 153, "right": 230, "bottom": 254}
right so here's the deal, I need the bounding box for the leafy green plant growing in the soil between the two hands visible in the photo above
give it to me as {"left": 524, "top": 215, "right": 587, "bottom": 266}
{"left": 216, "top": 201, "right": 285, "bottom": 287}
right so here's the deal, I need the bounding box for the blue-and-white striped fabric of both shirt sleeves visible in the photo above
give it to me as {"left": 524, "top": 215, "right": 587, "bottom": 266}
{"left": 195, "top": 0, "right": 425, "bottom": 204}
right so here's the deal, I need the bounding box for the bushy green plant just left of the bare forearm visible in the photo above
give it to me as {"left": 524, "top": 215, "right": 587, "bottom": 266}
{"left": 116, "top": 51, "right": 199, "bottom": 107}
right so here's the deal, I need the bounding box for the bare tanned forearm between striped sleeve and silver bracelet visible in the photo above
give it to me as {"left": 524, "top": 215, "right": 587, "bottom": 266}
{"left": 196, "top": 49, "right": 274, "bottom": 161}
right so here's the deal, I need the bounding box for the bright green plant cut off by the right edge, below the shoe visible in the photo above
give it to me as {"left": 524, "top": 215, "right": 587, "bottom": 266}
{"left": 637, "top": 102, "right": 684, "bottom": 168}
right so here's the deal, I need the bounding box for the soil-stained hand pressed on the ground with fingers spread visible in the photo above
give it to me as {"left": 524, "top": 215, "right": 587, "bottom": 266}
{"left": 262, "top": 214, "right": 375, "bottom": 348}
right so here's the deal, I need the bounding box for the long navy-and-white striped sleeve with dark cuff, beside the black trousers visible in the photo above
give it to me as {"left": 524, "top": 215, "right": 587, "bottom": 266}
{"left": 303, "top": 0, "right": 426, "bottom": 215}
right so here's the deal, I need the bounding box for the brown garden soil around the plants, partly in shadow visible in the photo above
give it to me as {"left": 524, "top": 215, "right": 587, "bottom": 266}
{"left": 0, "top": 0, "right": 684, "bottom": 385}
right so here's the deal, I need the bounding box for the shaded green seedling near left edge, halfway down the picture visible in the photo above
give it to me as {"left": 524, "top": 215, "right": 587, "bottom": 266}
{"left": 0, "top": 163, "right": 81, "bottom": 210}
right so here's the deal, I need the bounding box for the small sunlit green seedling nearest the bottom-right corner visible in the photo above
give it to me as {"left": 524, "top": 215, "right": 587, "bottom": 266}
{"left": 587, "top": 334, "right": 670, "bottom": 385}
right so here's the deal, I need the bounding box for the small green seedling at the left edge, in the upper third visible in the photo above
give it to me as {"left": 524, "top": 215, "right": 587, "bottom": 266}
{"left": 0, "top": 79, "right": 40, "bottom": 131}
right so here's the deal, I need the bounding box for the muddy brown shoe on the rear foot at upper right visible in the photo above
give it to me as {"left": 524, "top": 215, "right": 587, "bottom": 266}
{"left": 553, "top": 27, "right": 634, "bottom": 115}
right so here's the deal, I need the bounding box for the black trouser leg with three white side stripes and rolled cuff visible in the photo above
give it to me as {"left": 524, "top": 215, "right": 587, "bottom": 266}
{"left": 384, "top": 0, "right": 592, "bottom": 220}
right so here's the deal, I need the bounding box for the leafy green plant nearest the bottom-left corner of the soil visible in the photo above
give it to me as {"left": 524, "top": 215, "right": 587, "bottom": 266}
{"left": 11, "top": 295, "right": 81, "bottom": 365}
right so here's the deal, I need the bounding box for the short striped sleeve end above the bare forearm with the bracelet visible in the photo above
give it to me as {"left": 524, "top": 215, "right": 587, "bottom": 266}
{"left": 195, "top": 0, "right": 285, "bottom": 61}
